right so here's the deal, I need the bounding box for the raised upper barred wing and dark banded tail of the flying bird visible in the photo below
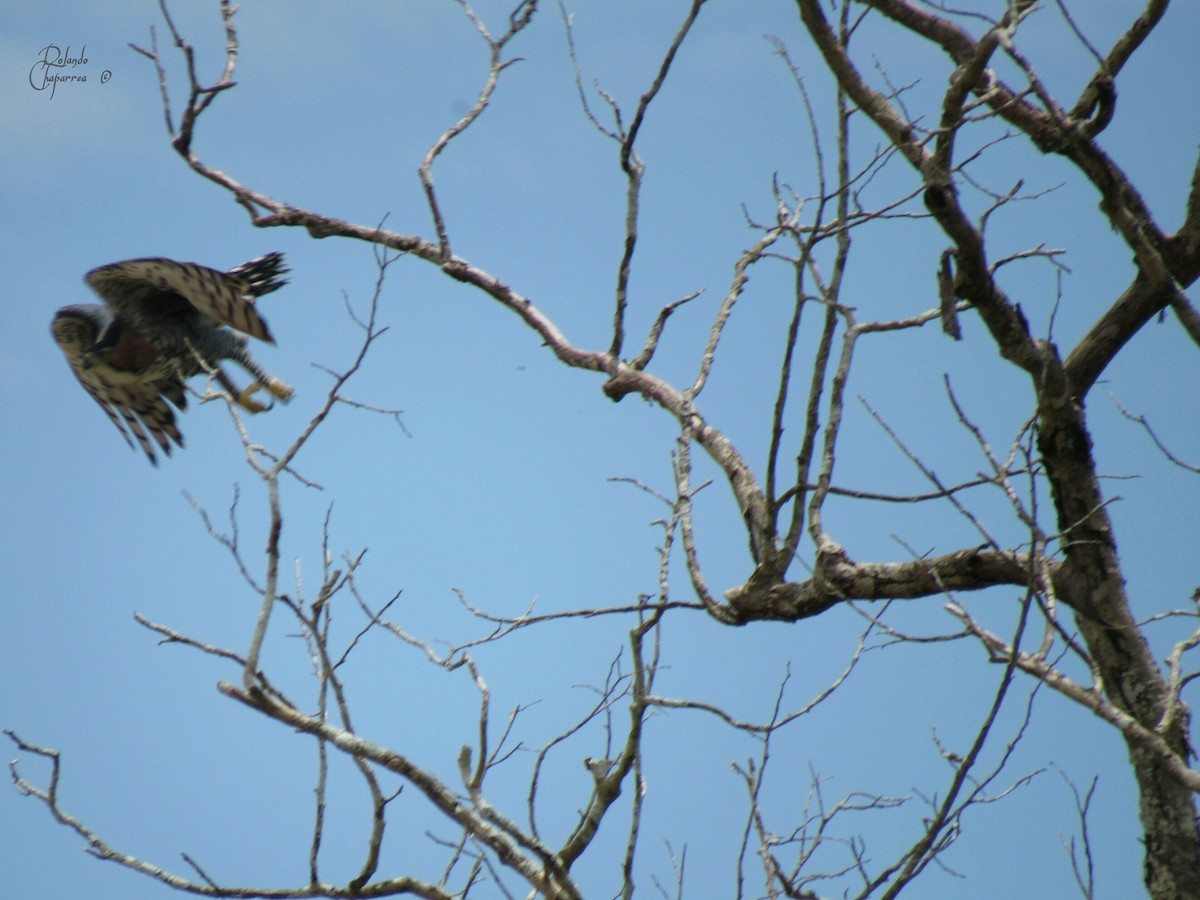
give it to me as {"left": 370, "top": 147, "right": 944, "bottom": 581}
{"left": 86, "top": 259, "right": 286, "bottom": 343}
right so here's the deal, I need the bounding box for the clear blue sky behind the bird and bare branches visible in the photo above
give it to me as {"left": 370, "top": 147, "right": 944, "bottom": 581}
{"left": 0, "top": 0, "right": 1200, "bottom": 900}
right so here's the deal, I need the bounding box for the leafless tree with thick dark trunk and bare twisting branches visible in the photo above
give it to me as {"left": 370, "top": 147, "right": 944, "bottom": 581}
{"left": 13, "top": 0, "right": 1200, "bottom": 899}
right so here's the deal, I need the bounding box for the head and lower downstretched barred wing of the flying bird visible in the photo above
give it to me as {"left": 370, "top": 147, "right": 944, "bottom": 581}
{"left": 50, "top": 307, "right": 184, "bottom": 466}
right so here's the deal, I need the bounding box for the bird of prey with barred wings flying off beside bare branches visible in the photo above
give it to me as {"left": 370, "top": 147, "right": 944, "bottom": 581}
{"left": 50, "top": 253, "right": 292, "bottom": 466}
